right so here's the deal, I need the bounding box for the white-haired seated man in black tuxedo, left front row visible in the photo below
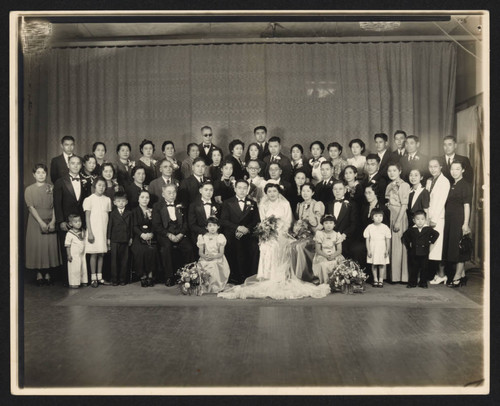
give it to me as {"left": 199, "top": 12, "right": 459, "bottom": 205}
{"left": 152, "top": 184, "right": 194, "bottom": 286}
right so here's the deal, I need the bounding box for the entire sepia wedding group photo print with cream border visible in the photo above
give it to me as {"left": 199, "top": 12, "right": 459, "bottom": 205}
{"left": 11, "top": 11, "right": 489, "bottom": 395}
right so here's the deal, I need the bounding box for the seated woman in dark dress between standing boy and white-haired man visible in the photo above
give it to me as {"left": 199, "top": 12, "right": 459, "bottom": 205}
{"left": 130, "top": 190, "right": 157, "bottom": 288}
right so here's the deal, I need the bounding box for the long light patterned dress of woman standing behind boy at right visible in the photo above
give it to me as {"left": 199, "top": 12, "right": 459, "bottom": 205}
{"left": 385, "top": 179, "right": 410, "bottom": 282}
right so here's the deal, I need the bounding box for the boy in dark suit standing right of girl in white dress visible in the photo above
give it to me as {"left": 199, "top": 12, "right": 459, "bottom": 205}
{"left": 106, "top": 192, "right": 132, "bottom": 287}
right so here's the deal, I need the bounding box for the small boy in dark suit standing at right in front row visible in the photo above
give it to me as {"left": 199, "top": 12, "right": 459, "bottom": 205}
{"left": 403, "top": 210, "right": 439, "bottom": 288}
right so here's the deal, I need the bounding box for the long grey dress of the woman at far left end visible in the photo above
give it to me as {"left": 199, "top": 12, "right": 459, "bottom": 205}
{"left": 24, "top": 183, "right": 61, "bottom": 269}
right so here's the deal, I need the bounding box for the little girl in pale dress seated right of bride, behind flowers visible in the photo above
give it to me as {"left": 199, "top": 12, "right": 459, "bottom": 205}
{"left": 312, "top": 214, "right": 343, "bottom": 283}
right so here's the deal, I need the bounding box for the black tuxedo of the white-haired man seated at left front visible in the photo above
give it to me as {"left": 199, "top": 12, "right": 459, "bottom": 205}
{"left": 152, "top": 199, "right": 194, "bottom": 279}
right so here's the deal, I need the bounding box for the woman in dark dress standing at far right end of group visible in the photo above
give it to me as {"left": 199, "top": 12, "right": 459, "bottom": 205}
{"left": 443, "top": 161, "right": 472, "bottom": 287}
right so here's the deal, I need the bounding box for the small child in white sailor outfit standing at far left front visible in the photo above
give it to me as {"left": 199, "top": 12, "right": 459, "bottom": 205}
{"left": 64, "top": 214, "right": 88, "bottom": 289}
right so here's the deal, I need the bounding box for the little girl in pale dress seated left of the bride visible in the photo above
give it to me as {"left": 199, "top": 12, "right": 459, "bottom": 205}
{"left": 196, "top": 217, "right": 229, "bottom": 293}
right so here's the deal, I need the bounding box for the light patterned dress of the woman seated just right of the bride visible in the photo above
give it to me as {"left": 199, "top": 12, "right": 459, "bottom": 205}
{"left": 291, "top": 199, "right": 325, "bottom": 282}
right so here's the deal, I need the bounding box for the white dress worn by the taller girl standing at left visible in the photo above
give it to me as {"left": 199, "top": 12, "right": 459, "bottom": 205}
{"left": 83, "top": 194, "right": 111, "bottom": 254}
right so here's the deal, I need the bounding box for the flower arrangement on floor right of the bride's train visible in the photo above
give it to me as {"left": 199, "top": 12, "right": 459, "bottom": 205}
{"left": 328, "top": 259, "right": 368, "bottom": 294}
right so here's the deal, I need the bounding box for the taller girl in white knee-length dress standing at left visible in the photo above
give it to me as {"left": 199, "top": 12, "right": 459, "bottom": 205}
{"left": 83, "top": 177, "right": 111, "bottom": 284}
